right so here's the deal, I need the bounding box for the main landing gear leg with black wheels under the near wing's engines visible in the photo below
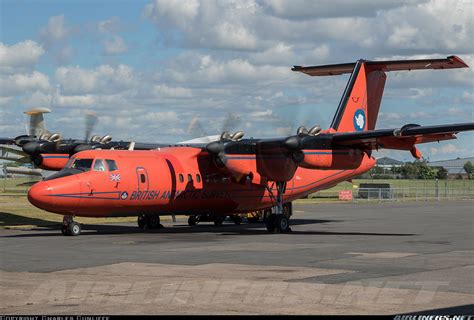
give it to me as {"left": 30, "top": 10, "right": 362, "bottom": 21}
{"left": 265, "top": 182, "right": 292, "bottom": 233}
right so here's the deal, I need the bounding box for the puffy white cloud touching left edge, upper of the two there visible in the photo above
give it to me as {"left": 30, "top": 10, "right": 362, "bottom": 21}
{"left": 0, "top": 40, "right": 44, "bottom": 73}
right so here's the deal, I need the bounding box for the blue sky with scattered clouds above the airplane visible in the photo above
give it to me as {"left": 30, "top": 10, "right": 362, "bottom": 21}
{"left": 0, "top": 0, "right": 474, "bottom": 161}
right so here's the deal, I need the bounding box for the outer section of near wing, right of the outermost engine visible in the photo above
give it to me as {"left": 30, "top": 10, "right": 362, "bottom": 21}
{"left": 332, "top": 123, "right": 474, "bottom": 150}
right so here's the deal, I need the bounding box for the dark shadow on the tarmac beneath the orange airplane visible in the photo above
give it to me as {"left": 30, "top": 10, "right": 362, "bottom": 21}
{"left": 2, "top": 219, "right": 414, "bottom": 238}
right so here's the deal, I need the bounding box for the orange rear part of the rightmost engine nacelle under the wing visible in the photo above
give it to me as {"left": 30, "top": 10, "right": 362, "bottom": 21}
{"left": 298, "top": 149, "right": 364, "bottom": 170}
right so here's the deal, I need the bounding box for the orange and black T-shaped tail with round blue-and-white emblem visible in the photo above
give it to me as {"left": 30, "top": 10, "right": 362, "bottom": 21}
{"left": 292, "top": 56, "right": 468, "bottom": 132}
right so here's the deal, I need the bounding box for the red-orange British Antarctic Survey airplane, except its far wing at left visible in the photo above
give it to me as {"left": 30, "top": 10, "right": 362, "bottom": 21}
{"left": 28, "top": 56, "right": 474, "bottom": 235}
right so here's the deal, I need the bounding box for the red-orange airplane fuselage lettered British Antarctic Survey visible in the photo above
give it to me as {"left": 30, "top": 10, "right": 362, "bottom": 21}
{"left": 28, "top": 147, "right": 375, "bottom": 217}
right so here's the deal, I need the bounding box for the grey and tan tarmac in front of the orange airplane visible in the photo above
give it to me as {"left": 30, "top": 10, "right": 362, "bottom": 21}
{"left": 0, "top": 201, "right": 474, "bottom": 315}
